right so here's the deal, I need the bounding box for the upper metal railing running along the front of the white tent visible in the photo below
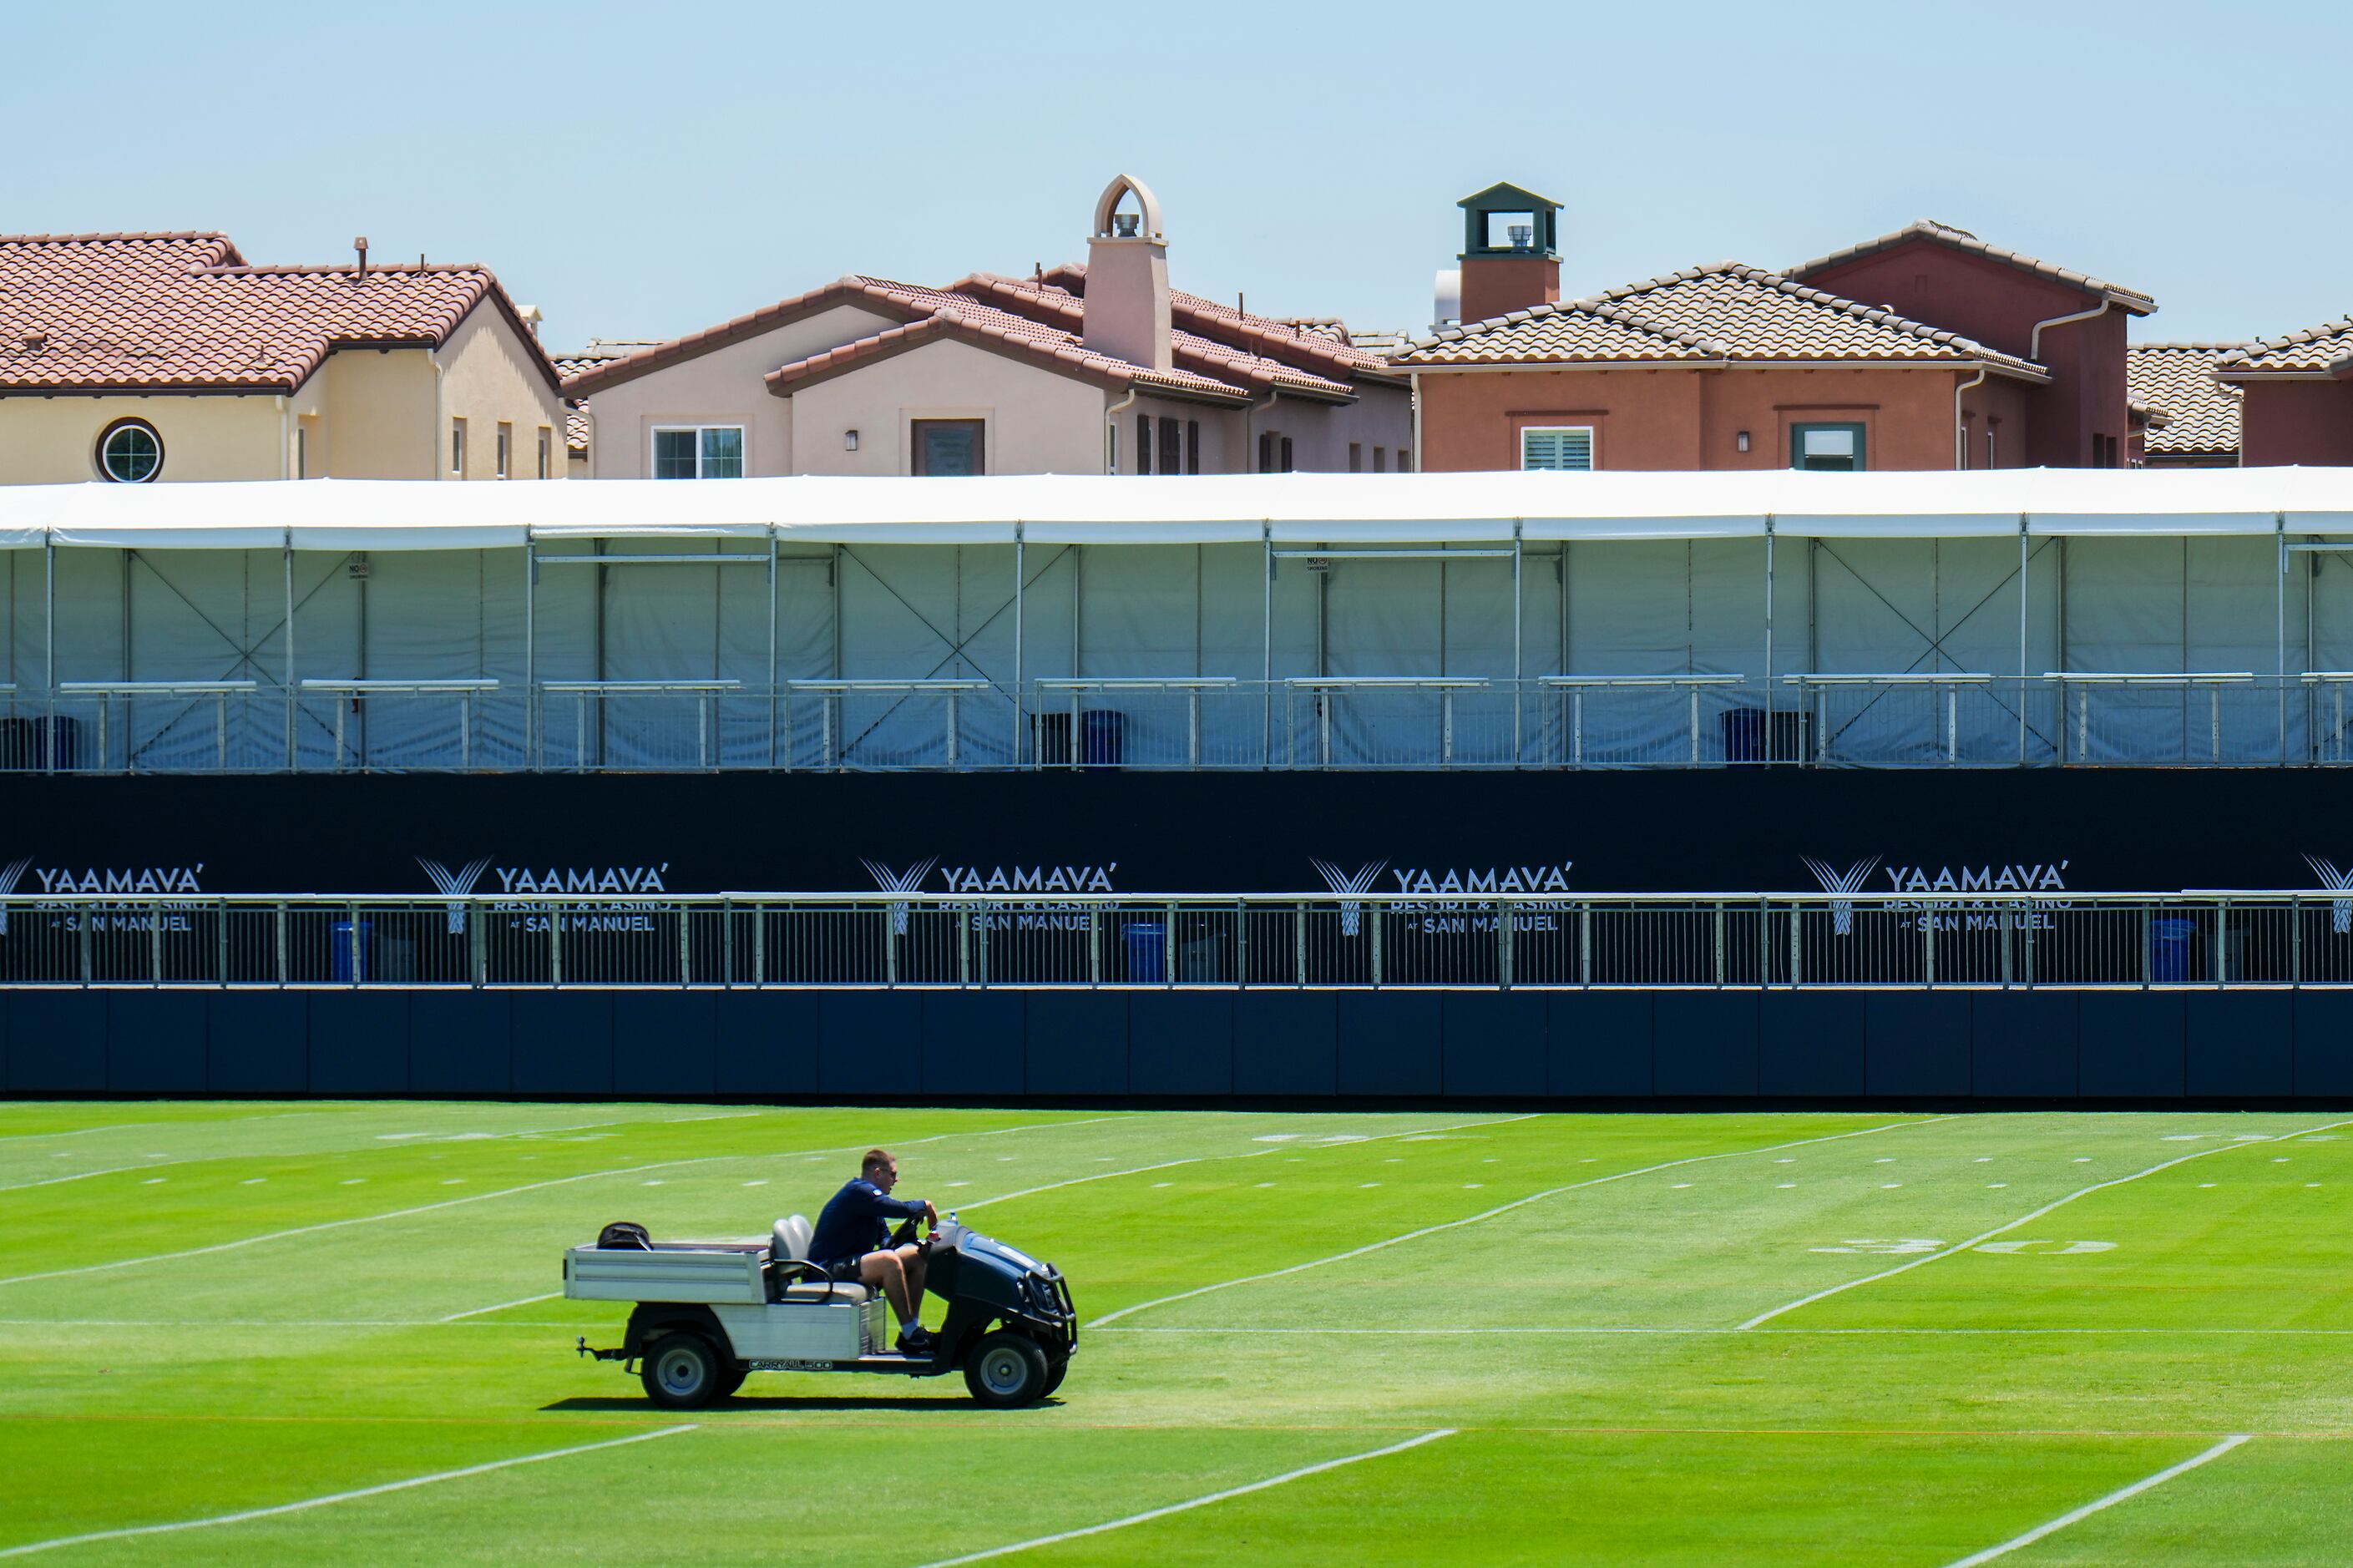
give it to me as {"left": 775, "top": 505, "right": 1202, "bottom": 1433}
{"left": 0, "top": 671, "right": 2353, "bottom": 772}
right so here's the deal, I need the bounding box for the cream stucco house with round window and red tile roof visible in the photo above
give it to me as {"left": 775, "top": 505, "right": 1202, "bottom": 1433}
{"left": 0, "top": 233, "right": 567, "bottom": 485}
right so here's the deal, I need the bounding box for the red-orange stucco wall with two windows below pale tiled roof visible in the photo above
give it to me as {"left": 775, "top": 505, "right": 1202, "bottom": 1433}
{"left": 1421, "top": 367, "right": 1986, "bottom": 473}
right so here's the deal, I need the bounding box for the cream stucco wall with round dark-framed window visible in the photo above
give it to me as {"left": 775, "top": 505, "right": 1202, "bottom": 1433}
{"left": 0, "top": 396, "right": 280, "bottom": 485}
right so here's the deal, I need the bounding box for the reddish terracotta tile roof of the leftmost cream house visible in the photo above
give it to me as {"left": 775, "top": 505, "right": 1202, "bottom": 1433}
{"left": 0, "top": 233, "right": 555, "bottom": 391}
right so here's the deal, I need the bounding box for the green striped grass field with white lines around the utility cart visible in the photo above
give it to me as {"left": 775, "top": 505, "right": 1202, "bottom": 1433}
{"left": 0, "top": 1104, "right": 2353, "bottom": 1568}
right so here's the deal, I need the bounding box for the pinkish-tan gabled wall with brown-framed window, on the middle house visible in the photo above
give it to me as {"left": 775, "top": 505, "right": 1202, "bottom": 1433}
{"left": 786, "top": 339, "right": 1106, "bottom": 473}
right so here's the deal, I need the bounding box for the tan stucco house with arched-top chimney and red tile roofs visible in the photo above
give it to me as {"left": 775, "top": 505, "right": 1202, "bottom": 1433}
{"left": 564, "top": 176, "right": 1412, "bottom": 478}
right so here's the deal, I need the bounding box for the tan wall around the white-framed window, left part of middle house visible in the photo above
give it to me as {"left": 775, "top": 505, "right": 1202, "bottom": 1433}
{"left": 589, "top": 306, "right": 898, "bottom": 478}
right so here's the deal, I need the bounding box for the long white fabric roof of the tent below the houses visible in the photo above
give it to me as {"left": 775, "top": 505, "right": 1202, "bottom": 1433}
{"left": 0, "top": 468, "right": 2353, "bottom": 551}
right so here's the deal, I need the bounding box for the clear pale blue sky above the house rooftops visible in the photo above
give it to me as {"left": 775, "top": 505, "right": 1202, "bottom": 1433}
{"left": 0, "top": 0, "right": 2353, "bottom": 348}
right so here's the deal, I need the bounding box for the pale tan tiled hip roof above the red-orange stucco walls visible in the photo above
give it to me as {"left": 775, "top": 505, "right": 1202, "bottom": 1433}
{"left": 1395, "top": 261, "right": 2047, "bottom": 379}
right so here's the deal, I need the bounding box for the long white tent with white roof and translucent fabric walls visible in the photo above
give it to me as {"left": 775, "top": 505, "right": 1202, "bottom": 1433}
{"left": 0, "top": 468, "right": 2353, "bottom": 765}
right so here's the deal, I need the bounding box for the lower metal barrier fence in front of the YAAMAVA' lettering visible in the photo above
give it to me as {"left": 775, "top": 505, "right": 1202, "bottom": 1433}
{"left": 13, "top": 888, "right": 2353, "bottom": 989}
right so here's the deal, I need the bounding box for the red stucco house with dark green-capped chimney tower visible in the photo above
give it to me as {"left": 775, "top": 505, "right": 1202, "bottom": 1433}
{"left": 1393, "top": 186, "right": 2155, "bottom": 471}
